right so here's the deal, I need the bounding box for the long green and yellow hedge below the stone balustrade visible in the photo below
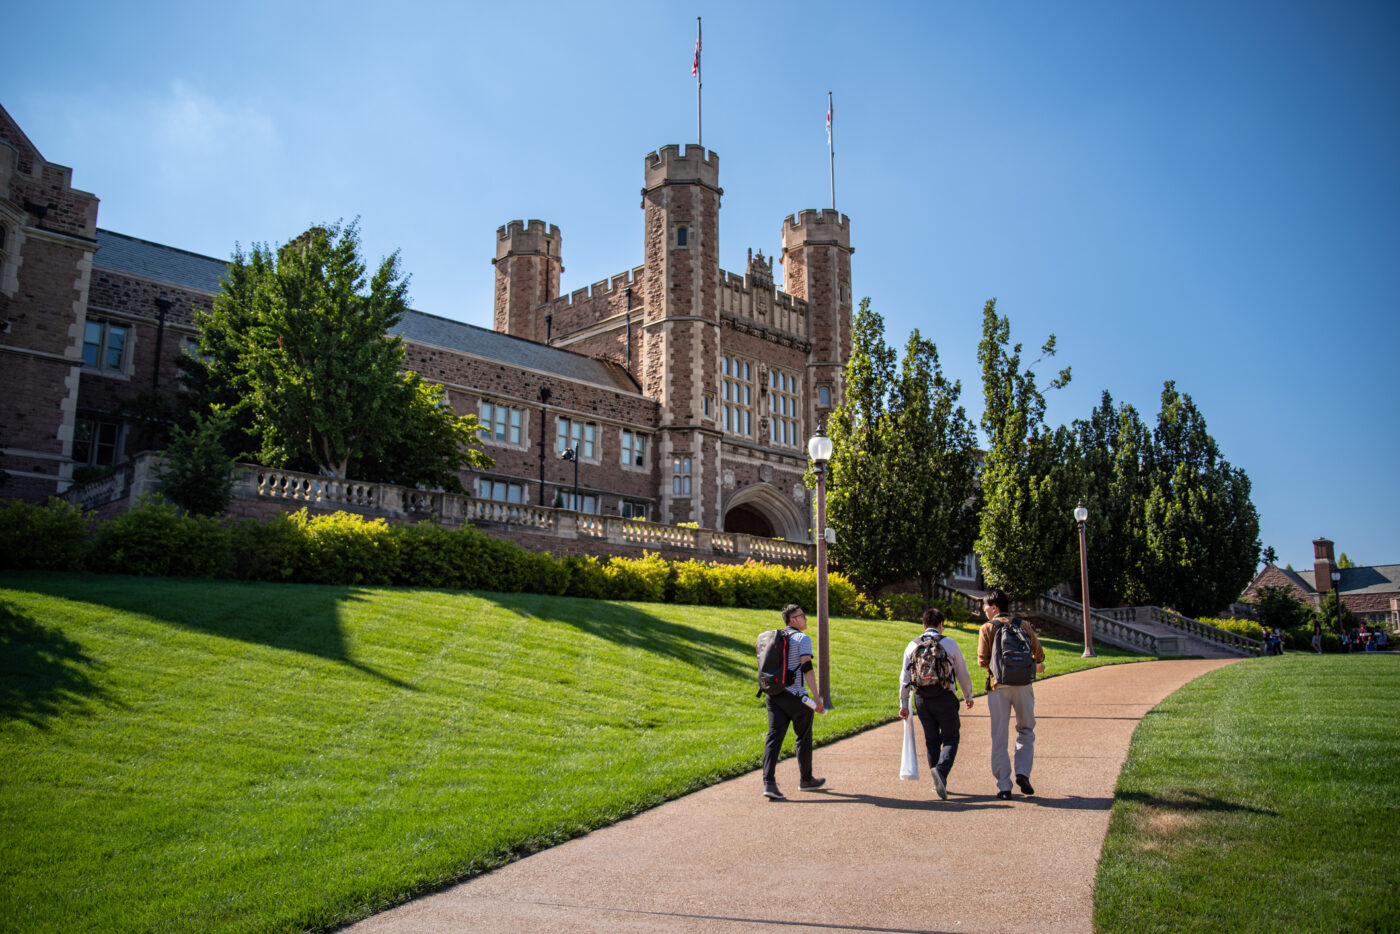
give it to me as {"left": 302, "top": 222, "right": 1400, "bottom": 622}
{"left": 0, "top": 496, "right": 862, "bottom": 619}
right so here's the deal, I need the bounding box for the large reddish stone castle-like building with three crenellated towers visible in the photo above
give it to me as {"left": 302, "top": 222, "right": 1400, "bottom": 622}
{"left": 0, "top": 108, "right": 853, "bottom": 541}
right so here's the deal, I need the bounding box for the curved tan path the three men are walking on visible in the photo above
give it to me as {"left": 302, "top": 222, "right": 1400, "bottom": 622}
{"left": 346, "top": 660, "right": 1231, "bottom": 934}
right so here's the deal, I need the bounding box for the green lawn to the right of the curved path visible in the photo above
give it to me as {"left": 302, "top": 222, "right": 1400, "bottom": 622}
{"left": 1095, "top": 653, "right": 1400, "bottom": 933}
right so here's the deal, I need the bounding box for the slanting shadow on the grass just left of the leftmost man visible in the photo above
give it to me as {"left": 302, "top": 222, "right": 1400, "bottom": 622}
{"left": 490, "top": 594, "right": 757, "bottom": 678}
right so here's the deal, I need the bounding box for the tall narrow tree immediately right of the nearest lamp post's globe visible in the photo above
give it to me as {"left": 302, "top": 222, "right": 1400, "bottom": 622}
{"left": 826, "top": 298, "right": 899, "bottom": 592}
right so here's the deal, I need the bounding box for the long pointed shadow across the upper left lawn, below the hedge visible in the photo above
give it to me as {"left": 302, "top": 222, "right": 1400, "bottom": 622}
{"left": 9, "top": 574, "right": 417, "bottom": 690}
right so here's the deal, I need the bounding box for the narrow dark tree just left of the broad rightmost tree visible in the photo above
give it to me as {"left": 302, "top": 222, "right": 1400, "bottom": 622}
{"left": 1074, "top": 391, "right": 1152, "bottom": 606}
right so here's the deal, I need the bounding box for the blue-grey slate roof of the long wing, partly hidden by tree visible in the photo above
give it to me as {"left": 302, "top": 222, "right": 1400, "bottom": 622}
{"left": 92, "top": 230, "right": 640, "bottom": 392}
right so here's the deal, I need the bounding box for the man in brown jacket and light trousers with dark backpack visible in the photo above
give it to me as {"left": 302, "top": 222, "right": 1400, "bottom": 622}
{"left": 977, "top": 590, "right": 1046, "bottom": 801}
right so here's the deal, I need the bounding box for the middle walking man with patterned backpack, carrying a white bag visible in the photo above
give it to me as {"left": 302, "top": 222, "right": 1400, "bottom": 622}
{"left": 899, "top": 609, "right": 972, "bottom": 800}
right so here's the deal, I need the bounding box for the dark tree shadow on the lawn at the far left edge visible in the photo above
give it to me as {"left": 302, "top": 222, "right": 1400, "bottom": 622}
{"left": 0, "top": 602, "right": 113, "bottom": 730}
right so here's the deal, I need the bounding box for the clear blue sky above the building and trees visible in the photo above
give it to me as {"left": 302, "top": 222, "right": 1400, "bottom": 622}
{"left": 0, "top": 0, "right": 1400, "bottom": 569}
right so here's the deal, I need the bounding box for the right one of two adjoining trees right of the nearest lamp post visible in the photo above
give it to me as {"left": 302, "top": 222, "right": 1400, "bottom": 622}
{"left": 883, "top": 329, "right": 981, "bottom": 606}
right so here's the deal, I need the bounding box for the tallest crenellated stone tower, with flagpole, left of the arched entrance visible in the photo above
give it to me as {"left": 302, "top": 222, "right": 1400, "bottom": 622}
{"left": 638, "top": 146, "right": 724, "bottom": 527}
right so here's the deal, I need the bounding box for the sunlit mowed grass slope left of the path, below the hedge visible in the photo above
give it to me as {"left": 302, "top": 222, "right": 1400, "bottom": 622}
{"left": 0, "top": 574, "right": 1134, "bottom": 933}
